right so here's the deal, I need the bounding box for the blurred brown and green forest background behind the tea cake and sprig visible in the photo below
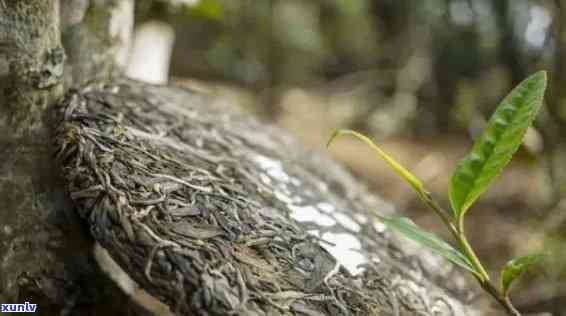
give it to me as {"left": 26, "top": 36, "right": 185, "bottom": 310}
{"left": 133, "top": 0, "right": 566, "bottom": 315}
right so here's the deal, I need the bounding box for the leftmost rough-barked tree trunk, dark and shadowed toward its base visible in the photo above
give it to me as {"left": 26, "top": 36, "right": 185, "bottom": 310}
{"left": 0, "top": 0, "right": 138, "bottom": 315}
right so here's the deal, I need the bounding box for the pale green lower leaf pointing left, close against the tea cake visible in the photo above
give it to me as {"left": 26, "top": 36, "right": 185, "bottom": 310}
{"left": 378, "top": 215, "right": 479, "bottom": 274}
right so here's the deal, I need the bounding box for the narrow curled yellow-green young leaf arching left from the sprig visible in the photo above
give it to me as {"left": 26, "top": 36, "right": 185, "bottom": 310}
{"left": 326, "top": 130, "right": 425, "bottom": 196}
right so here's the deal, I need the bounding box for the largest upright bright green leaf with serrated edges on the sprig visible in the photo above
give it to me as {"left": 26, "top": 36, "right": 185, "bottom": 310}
{"left": 450, "top": 71, "right": 546, "bottom": 220}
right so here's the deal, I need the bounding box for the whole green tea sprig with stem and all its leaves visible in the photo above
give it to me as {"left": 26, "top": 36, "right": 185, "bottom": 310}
{"left": 328, "top": 71, "right": 546, "bottom": 316}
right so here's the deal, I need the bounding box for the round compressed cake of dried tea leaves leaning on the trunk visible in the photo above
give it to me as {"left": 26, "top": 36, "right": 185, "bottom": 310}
{"left": 56, "top": 80, "right": 494, "bottom": 316}
